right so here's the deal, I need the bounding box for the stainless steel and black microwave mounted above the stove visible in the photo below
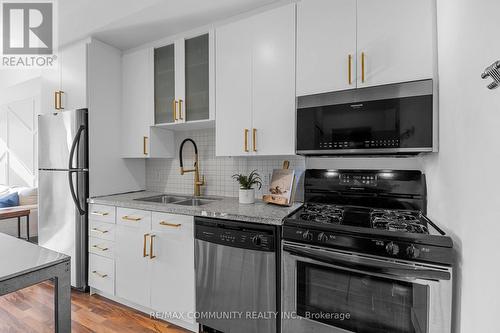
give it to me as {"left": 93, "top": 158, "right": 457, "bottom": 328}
{"left": 296, "top": 80, "right": 437, "bottom": 155}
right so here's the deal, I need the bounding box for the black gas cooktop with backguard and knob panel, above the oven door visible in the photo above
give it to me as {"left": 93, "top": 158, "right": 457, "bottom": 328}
{"left": 283, "top": 169, "right": 453, "bottom": 265}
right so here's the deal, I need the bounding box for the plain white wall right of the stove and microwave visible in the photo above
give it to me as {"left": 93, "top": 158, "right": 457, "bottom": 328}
{"left": 424, "top": 0, "right": 500, "bottom": 333}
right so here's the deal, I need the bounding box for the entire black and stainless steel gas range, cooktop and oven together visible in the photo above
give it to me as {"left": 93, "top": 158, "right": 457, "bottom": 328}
{"left": 281, "top": 170, "right": 453, "bottom": 333}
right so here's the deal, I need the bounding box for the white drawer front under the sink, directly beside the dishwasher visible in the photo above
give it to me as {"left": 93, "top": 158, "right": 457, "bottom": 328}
{"left": 152, "top": 212, "right": 194, "bottom": 238}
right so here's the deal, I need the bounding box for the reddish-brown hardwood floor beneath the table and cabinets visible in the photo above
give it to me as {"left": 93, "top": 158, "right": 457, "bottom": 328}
{"left": 0, "top": 282, "right": 189, "bottom": 333}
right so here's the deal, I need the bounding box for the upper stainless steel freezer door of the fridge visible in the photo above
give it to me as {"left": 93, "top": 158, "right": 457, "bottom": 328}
{"left": 38, "top": 109, "right": 88, "bottom": 170}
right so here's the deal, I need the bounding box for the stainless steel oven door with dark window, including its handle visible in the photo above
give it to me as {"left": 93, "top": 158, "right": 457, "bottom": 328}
{"left": 282, "top": 242, "right": 452, "bottom": 333}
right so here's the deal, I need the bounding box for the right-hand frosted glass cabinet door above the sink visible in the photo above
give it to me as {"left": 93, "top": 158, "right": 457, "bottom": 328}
{"left": 184, "top": 34, "right": 209, "bottom": 121}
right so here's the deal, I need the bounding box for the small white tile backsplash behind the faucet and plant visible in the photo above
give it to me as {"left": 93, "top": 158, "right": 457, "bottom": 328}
{"left": 146, "top": 129, "right": 305, "bottom": 200}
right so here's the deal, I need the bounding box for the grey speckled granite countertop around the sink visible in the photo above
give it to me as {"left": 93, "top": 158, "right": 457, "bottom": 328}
{"left": 89, "top": 191, "right": 302, "bottom": 225}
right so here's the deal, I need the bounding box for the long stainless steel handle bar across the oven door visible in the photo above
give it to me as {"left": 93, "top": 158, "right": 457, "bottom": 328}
{"left": 283, "top": 244, "right": 451, "bottom": 281}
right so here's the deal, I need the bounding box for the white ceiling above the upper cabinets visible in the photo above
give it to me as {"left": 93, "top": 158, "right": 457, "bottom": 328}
{"left": 58, "top": 0, "right": 280, "bottom": 50}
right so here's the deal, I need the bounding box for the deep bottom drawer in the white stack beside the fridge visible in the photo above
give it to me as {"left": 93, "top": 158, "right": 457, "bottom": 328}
{"left": 89, "top": 254, "right": 115, "bottom": 295}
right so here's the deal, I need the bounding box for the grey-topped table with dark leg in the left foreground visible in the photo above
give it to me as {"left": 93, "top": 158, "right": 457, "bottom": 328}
{"left": 0, "top": 233, "right": 71, "bottom": 333}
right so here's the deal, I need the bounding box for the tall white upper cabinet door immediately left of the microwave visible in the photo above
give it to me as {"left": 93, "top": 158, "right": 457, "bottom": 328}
{"left": 251, "top": 5, "right": 295, "bottom": 155}
